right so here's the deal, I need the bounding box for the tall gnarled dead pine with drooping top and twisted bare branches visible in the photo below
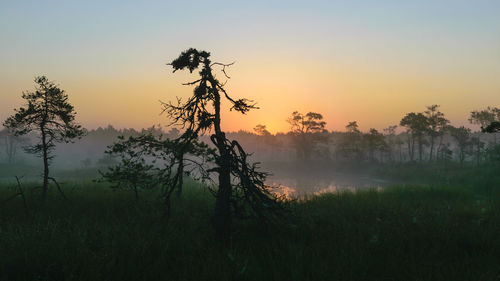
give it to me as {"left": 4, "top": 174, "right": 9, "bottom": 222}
{"left": 164, "top": 48, "right": 283, "bottom": 241}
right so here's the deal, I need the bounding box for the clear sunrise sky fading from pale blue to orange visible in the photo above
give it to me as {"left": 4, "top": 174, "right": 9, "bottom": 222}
{"left": 0, "top": 0, "right": 500, "bottom": 132}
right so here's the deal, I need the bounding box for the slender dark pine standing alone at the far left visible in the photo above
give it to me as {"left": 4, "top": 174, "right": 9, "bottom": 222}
{"left": 3, "top": 76, "right": 85, "bottom": 200}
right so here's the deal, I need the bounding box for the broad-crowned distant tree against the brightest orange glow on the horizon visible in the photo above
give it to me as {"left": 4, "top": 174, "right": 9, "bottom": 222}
{"left": 287, "top": 111, "right": 328, "bottom": 161}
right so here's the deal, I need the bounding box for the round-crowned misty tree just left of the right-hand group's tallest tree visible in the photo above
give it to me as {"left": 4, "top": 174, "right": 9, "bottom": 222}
{"left": 399, "top": 112, "right": 429, "bottom": 161}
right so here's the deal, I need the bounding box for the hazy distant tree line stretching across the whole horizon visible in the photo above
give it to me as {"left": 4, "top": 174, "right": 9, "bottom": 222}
{"left": 0, "top": 105, "right": 500, "bottom": 168}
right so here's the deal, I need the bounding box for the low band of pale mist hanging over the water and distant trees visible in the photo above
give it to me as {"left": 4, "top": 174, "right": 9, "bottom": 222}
{"left": 0, "top": 125, "right": 497, "bottom": 196}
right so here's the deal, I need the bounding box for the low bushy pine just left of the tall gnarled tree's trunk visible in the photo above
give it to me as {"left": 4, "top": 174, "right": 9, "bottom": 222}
{"left": 100, "top": 131, "right": 213, "bottom": 201}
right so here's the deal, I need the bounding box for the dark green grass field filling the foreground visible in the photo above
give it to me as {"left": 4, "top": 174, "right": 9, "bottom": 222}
{"left": 0, "top": 178, "right": 500, "bottom": 281}
